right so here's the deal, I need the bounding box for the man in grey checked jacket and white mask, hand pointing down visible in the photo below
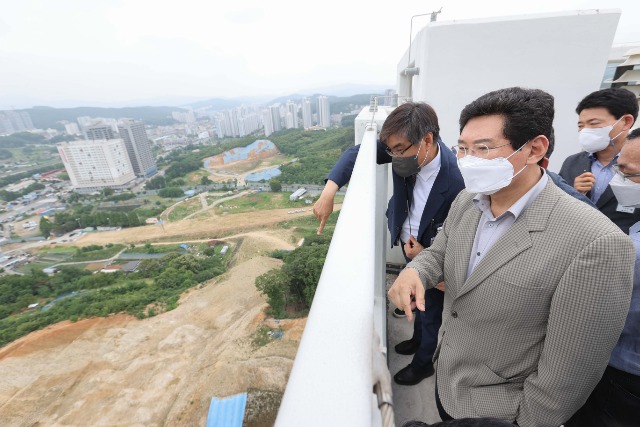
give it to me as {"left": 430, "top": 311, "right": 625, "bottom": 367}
{"left": 389, "top": 88, "right": 634, "bottom": 427}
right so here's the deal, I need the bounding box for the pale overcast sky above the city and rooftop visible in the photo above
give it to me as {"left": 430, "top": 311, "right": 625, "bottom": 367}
{"left": 0, "top": 0, "right": 640, "bottom": 109}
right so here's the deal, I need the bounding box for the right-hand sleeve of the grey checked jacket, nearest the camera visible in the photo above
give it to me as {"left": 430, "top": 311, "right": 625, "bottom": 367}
{"left": 517, "top": 232, "right": 635, "bottom": 427}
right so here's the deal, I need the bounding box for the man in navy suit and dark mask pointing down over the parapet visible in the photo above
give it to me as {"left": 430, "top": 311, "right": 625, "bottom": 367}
{"left": 313, "top": 102, "right": 464, "bottom": 385}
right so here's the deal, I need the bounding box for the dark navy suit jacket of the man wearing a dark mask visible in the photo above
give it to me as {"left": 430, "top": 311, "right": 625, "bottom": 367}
{"left": 327, "top": 139, "right": 464, "bottom": 248}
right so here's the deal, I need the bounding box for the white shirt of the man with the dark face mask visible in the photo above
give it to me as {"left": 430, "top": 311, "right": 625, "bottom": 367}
{"left": 400, "top": 146, "right": 442, "bottom": 242}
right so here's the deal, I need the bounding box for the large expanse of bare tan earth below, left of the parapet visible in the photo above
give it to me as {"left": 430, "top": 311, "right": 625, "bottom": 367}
{"left": 0, "top": 216, "right": 309, "bottom": 426}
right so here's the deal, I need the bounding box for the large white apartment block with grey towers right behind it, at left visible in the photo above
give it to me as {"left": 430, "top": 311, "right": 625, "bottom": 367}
{"left": 57, "top": 118, "right": 157, "bottom": 193}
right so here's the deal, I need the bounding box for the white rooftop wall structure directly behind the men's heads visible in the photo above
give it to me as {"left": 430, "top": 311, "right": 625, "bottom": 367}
{"left": 397, "top": 9, "right": 621, "bottom": 171}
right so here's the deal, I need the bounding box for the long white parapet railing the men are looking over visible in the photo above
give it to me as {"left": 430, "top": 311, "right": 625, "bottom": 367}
{"left": 276, "top": 123, "right": 393, "bottom": 427}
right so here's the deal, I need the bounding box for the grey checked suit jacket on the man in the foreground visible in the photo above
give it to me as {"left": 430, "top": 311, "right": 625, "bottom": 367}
{"left": 407, "top": 180, "right": 634, "bottom": 427}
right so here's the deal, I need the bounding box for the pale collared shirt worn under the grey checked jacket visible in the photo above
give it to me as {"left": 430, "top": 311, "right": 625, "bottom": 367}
{"left": 467, "top": 172, "right": 549, "bottom": 277}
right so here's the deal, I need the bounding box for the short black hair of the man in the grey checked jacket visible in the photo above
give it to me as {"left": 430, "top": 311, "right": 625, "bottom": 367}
{"left": 460, "top": 87, "right": 555, "bottom": 151}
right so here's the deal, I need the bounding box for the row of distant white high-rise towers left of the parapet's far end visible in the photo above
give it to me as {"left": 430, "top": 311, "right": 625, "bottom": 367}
{"left": 212, "top": 96, "right": 331, "bottom": 138}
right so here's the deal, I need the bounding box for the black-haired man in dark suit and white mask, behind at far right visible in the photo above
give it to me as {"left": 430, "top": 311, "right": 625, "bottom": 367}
{"left": 560, "top": 88, "right": 640, "bottom": 234}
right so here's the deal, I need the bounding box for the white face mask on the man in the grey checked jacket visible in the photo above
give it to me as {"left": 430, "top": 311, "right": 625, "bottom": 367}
{"left": 458, "top": 145, "right": 527, "bottom": 195}
